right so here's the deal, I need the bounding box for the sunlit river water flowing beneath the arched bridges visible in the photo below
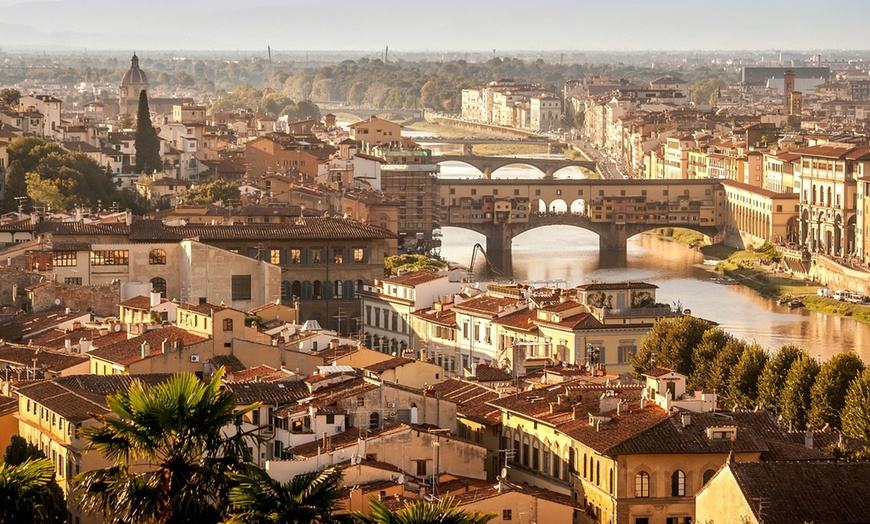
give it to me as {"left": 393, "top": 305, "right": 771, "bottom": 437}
{"left": 424, "top": 144, "right": 870, "bottom": 363}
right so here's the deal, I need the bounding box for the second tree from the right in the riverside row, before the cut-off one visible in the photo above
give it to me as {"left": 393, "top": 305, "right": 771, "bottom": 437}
{"left": 809, "top": 353, "right": 864, "bottom": 429}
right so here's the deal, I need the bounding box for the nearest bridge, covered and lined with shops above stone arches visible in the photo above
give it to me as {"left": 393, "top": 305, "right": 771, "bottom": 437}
{"left": 439, "top": 179, "right": 727, "bottom": 269}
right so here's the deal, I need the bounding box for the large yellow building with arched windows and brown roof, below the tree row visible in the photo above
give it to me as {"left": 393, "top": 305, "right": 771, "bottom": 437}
{"left": 489, "top": 370, "right": 828, "bottom": 524}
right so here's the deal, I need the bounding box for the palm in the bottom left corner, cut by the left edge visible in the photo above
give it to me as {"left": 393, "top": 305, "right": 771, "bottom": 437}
{"left": 0, "top": 458, "right": 66, "bottom": 524}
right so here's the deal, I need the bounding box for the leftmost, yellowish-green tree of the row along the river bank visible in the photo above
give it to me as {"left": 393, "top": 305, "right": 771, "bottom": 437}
{"left": 631, "top": 315, "right": 710, "bottom": 376}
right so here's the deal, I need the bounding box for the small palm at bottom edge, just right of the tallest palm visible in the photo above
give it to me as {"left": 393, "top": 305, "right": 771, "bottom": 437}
{"left": 227, "top": 468, "right": 350, "bottom": 524}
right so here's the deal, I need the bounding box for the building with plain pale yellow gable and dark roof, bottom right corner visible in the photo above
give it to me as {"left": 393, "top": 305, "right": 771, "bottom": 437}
{"left": 695, "top": 457, "right": 870, "bottom": 524}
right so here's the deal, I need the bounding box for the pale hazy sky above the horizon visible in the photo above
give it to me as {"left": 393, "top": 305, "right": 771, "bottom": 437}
{"left": 0, "top": 0, "right": 870, "bottom": 51}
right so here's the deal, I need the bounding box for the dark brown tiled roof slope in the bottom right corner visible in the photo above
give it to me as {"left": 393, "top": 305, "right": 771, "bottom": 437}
{"left": 728, "top": 462, "right": 870, "bottom": 524}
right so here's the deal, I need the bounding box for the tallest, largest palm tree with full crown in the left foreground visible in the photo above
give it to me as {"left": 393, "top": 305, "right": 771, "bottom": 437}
{"left": 76, "top": 368, "right": 259, "bottom": 524}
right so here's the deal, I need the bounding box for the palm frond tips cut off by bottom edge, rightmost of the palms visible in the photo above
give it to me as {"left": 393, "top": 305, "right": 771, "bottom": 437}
{"left": 351, "top": 497, "right": 498, "bottom": 524}
